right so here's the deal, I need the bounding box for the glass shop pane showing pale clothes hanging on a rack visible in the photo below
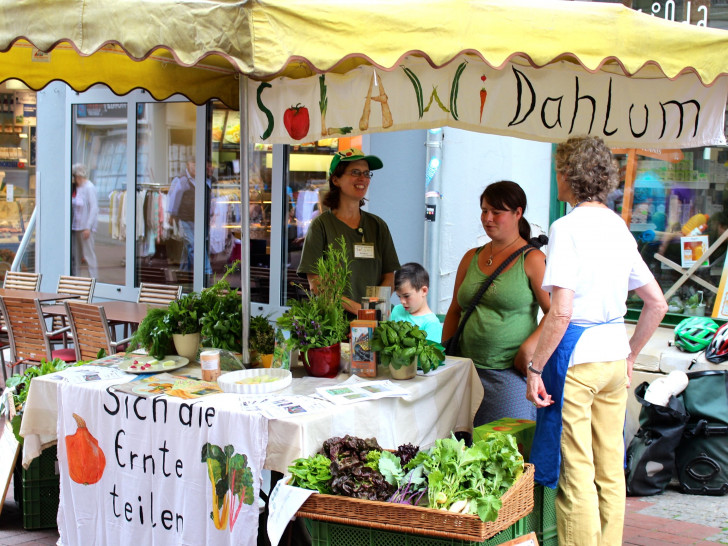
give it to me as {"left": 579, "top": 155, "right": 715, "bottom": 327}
{"left": 134, "top": 102, "right": 199, "bottom": 292}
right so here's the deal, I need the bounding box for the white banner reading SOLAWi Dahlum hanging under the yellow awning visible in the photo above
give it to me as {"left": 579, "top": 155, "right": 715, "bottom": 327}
{"left": 248, "top": 56, "right": 728, "bottom": 149}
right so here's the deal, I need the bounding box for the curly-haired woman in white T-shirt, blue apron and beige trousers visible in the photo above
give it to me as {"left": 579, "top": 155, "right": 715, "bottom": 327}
{"left": 526, "top": 137, "right": 667, "bottom": 546}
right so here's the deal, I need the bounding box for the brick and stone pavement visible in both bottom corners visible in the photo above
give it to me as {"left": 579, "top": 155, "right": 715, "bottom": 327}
{"left": 0, "top": 480, "right": 728, "bottom": 546}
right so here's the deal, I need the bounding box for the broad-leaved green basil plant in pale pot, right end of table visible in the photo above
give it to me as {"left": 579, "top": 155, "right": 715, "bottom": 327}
{"left": 372, "top": 320, "right": 445, "bottom": 379}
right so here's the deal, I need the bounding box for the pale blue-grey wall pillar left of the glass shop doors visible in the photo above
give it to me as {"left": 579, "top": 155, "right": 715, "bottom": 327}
{"left": 36, "top": 82, "right": 71, "bottom": 292}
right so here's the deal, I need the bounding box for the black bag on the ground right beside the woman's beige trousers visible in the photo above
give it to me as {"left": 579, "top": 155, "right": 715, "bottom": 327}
{"left": 625, "top": 381, "right": 688, "bottom": 496}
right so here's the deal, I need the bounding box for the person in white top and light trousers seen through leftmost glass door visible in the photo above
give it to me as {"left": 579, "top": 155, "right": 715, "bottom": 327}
{"left": 71, "top": 163, "right": 99, "bottom": 278}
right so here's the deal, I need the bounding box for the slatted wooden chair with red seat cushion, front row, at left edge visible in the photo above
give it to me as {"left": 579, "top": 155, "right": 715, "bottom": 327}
{"left": 0, "top": 297, "right": 76, "bottom": 372}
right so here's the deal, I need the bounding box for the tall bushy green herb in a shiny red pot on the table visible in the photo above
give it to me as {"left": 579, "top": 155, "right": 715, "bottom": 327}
{"left": 277, "top": 237, "right": 351, "bottom": 377}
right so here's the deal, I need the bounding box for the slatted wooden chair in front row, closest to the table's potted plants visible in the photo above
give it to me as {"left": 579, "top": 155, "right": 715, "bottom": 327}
{"left": 63, "top": 300, "right": 129, "bottom": 361}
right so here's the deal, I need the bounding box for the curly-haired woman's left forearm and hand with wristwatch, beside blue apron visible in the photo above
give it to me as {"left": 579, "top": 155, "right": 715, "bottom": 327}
{"left": 526, "top": 286, "right": 574, "bottom": 408}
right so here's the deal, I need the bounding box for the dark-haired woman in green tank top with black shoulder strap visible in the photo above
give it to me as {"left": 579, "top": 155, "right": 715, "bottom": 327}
{"left": 442, "top": 180, "right": 549, "bottom": 427}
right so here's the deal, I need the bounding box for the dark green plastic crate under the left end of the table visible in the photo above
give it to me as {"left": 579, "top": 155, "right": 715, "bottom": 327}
{"left": 21, "top": 446, "right": 60, "bottom": 529}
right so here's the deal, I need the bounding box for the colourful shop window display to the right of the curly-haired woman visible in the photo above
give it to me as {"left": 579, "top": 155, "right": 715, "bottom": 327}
{"left": 608, "top": 148, "right": 728, "bottom": 320}
